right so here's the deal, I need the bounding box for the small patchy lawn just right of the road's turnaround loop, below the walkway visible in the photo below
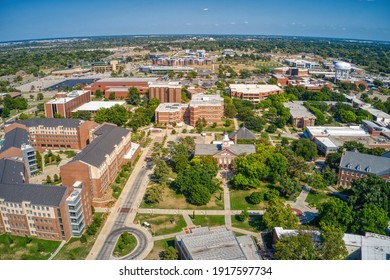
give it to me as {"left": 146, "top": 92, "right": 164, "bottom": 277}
{"left": 135, "top": 214, "right": 187, "bottom": 236}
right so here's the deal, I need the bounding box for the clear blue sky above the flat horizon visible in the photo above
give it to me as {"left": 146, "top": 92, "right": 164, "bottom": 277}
{"left": 0, "top": 0, "right": 390, "bottom": 41}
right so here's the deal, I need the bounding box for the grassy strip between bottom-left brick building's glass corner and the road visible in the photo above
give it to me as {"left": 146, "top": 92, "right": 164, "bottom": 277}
{"left": 54, "top": 213, "right": 107, "bottom": 260}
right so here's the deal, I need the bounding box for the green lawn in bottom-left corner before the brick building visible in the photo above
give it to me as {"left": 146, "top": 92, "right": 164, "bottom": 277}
{"left": 0, "top": 234, "right": 61, "bottom": 260}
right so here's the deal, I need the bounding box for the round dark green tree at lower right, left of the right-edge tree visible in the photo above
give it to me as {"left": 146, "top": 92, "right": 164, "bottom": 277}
{"left": 318, "top": 198, "right": 353, "bottom": 232}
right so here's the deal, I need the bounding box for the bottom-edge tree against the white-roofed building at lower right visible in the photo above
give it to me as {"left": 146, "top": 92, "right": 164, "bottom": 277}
{"left": 317, "top": 225, "right": 348, "bottom": 260}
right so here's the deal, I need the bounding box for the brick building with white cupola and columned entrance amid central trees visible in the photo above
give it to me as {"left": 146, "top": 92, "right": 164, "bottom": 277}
{"left": 194, "top": 133, "right": 256, "bottom": 169}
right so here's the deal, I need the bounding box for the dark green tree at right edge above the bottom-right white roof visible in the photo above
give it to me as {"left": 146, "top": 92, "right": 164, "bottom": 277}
{"left": 352, "top": 204, "right": 389, "bottom": 234}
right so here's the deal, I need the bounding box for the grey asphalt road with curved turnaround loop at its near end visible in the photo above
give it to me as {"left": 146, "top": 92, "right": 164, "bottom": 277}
{"left": 96, "top": 167, "right": 148, "bottom": 260}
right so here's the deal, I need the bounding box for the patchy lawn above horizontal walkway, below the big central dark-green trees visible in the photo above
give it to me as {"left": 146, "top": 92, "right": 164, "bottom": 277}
{"left": 141, "top": 188, "right": 224, "bottom": 210}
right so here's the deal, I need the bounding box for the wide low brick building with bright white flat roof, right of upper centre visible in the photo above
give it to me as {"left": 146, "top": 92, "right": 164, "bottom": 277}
{"left": 229, "top": 84, "right": 282, "bottom": 103}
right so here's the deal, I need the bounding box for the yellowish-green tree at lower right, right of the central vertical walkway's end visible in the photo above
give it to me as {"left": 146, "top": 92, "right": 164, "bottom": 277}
{"left": 263, "top": 199, "right": 298, "bottom": 229}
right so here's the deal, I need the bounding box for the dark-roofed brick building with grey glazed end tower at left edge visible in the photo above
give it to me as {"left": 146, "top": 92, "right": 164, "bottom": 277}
{"left": 0, "top": 127, "right": 38, "bottom": 176}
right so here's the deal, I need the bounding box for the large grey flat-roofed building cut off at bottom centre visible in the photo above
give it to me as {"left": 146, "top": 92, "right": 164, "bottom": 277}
{"left": 175, "top": 227, "right": 261, "bottom": 260}
